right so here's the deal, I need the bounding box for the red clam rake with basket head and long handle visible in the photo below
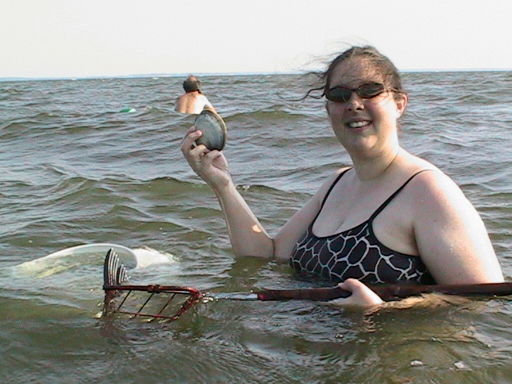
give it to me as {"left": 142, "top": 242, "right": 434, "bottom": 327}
{"left": 103, "top": 249, "right": 512, "bottom": 321}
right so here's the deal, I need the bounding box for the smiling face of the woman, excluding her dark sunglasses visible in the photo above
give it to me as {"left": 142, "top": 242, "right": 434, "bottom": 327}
{"left": 326, "top": 57, "right": 407, "bottom": 156}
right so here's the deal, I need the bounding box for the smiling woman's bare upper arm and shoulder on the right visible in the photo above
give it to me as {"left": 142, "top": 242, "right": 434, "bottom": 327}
{"left": 413, "top": 172, "right": 503, "bottom": 284}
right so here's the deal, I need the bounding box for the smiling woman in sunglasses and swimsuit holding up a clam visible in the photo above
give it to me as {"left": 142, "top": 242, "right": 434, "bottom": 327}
{"left": 182, "top": 47, "right": 503, "bottom": 306}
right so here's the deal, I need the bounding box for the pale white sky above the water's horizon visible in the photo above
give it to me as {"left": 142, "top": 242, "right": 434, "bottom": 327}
{"left": 0, "top": 0, "right": 512, "bottom": 78}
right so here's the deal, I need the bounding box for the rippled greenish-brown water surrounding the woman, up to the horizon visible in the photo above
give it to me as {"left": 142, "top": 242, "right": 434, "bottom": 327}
{"left": 0, "top": 72, "right": 512, "bottom": 384}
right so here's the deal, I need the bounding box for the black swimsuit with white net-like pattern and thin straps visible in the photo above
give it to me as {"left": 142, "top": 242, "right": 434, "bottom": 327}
{"left": 290, "top": 170, "right": 434, "bottom": 284}
